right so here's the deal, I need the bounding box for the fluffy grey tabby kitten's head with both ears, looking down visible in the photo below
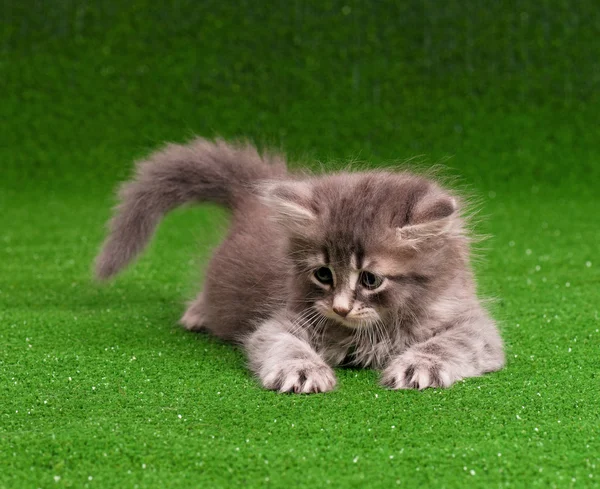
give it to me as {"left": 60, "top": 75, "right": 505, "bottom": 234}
{"left": 263, "top": 172, "right": 468, "bottom": 329}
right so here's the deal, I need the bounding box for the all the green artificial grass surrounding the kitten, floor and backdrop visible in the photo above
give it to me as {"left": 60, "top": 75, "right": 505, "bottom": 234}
{"left": 0, "top": 0, "right": 600, "bottom": 489}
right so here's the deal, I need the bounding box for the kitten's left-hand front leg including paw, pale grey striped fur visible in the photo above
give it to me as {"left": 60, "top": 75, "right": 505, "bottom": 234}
{"left": 245, "top": 312, "right": 337, "bottom": 394}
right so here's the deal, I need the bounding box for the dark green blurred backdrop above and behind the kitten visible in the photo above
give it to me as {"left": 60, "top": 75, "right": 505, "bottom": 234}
{"left": 0, "top": 0, "right": 600, "bottom": 195}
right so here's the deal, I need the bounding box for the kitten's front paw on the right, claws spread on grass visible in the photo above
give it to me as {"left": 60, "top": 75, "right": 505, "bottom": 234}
{"left": 381, "top": 351, "right": 460, "bottom": 389}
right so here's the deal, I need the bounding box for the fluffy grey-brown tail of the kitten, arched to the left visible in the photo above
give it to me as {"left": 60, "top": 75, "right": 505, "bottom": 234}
{"left": 96, "top": 138, "right": 286, "bottom": 279}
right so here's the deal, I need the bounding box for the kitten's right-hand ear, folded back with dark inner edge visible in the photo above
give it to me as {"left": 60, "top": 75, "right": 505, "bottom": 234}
{"left": 396, "top": 192, "right": 461, "bottom": 246}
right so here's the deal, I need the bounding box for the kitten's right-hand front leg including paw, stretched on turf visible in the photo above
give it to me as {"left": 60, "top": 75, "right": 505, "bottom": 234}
{"left": 381, "top": 316, "right": 504, "bottom": 389}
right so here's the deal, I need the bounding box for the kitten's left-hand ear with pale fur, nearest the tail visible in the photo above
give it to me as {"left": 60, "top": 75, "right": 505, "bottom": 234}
{"left": 259, "top": 181, "right": 317, "bottom": 229}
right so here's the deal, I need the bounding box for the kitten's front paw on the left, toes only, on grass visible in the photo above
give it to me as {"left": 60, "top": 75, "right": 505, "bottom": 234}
{"left": 261, "top": 360, "right": 337, "bottom": 394}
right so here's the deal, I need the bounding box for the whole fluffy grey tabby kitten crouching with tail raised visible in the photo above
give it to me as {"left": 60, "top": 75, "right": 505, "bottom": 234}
{"left": 96, "top": 139, "right": 504, "bottom": 393}
